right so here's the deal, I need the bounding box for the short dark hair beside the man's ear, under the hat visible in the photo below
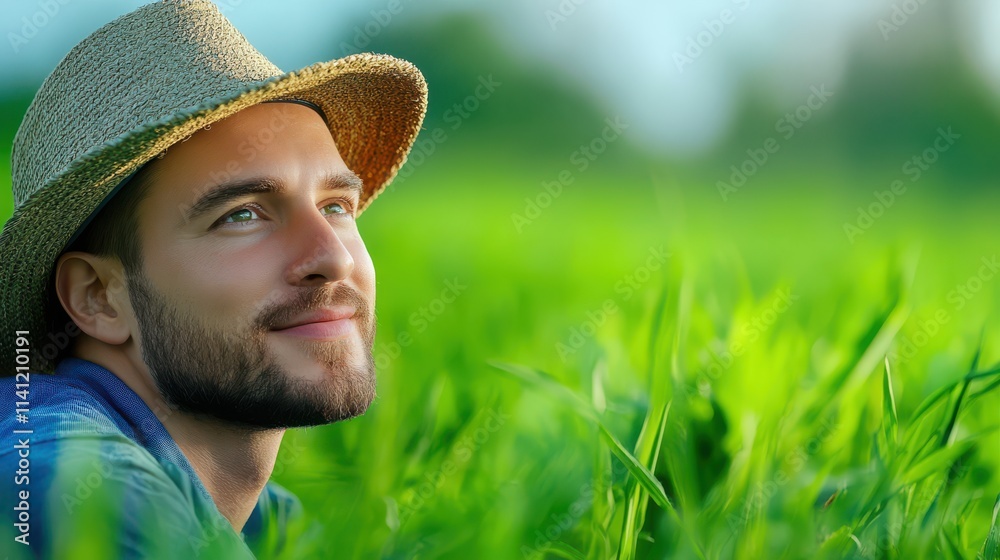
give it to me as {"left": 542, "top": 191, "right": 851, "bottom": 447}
{"left": 45, "top": 162, "right": 155, "bottom": 365}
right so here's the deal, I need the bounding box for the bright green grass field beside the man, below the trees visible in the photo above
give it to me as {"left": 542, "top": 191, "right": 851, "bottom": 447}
{"left": 254, "top": 154, "right": 1000, "bottom": 560}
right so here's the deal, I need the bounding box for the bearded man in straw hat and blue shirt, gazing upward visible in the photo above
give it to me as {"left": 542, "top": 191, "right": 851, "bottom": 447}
{"left": 0, "top": 0, "right": 426, "bottom": 558}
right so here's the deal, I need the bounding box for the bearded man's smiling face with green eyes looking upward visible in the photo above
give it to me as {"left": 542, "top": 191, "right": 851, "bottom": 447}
{"left": 125, "top": 103, "right": 375, "bottom": 428}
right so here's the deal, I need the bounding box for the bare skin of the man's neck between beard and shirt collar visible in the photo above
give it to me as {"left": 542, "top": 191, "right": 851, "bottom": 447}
{"left": 76, "top": 345, "right": 284, "bottom": 533}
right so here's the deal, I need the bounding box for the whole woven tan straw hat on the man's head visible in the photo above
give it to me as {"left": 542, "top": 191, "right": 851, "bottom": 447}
{"left": 0, "top": 0, "right": 427, "bottom": 375}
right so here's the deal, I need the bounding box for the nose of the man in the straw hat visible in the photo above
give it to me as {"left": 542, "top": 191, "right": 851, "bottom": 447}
{"left": 286, "top": 209, "right": 354, "bottom": 286}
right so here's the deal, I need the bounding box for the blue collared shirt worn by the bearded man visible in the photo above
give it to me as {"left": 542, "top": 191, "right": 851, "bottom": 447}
{"left": 0, "top": 358, "right": 301, "bottom": 559}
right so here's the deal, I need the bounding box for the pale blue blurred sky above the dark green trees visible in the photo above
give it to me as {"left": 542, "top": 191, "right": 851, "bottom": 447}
{"left": 0, "top": 0, "right": 1000, "bottom": 156}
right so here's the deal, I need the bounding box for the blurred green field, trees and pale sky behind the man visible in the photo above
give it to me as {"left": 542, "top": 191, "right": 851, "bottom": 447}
{"left": 0, "top": 0, "right": 1000, "bottom": 558}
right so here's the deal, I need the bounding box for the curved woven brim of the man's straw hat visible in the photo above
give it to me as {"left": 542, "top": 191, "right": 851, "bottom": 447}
{"left": 0, "top": 53, "right": 427, "bottom": 375}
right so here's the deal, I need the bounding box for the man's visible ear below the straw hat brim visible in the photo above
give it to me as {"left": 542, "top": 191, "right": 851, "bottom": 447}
{"left": 55, "top": 251, "right": 132, "bottom": 345}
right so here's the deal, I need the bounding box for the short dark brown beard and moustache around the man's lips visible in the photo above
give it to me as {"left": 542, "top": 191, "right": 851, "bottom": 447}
{"left": 125, "top": 271, "right": 375, "bottom": 429}
